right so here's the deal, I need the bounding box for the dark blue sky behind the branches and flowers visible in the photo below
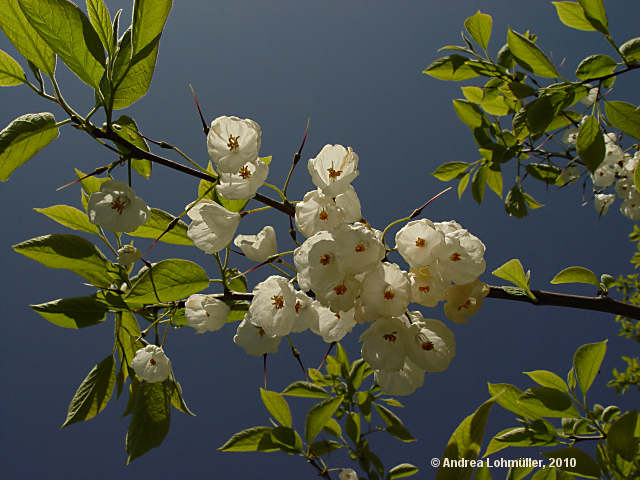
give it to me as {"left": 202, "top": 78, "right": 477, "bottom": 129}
{"left": 0, "top": 0, "right": 640, "bottom": 479}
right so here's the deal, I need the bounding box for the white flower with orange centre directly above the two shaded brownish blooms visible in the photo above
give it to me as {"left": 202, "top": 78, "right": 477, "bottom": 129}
{"left": 360, "top": 262, "right": 411, "bottom": 317}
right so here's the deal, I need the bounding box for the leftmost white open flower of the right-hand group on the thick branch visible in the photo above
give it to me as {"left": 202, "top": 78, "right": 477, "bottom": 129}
{"left": 396, "top": 218, "right": 444, "bottom": 268}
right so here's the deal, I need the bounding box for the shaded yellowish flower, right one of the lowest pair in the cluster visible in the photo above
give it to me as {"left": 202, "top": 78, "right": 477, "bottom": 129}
{"left": 407, "top": 311, "right": 456, "bottom": 372}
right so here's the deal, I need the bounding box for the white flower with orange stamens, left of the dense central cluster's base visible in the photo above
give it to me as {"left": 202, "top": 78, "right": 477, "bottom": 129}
{"left": 249, "top": 275, "right": 296, "bottom": 337}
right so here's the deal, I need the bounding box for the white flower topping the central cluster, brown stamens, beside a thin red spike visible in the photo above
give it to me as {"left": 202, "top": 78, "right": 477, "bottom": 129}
{"left": 308, "top": 145, "right": 360, "bottom": 197}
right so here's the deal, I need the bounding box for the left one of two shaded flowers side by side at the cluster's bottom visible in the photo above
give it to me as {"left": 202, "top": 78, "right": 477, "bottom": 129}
{"left": 360, "top": 317, "right": 409, "bottom": 371}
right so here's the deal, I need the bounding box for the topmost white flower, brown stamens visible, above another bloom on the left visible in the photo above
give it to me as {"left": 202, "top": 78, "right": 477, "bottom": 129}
{"left": 207, "top": 116, "right": 262, "bottom": 173}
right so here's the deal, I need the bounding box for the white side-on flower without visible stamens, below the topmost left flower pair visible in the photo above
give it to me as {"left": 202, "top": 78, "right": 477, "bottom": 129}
{"left": 187, "top": 199, "right": 240, "bottom": 253}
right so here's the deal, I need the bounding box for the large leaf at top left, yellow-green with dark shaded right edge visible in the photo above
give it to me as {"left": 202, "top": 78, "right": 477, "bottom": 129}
{"left": 19, "top": 0, "right": 105, "bottom": 89}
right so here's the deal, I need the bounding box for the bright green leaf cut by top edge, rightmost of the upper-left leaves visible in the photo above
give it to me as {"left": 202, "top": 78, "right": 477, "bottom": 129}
{"left": 131, "top": 0, "right": 173, "bottom": 58}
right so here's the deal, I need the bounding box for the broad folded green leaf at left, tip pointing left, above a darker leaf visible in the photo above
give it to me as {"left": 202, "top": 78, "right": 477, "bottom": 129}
{"left": 13, "top": 234, "right": 113, "bottom": 287}
